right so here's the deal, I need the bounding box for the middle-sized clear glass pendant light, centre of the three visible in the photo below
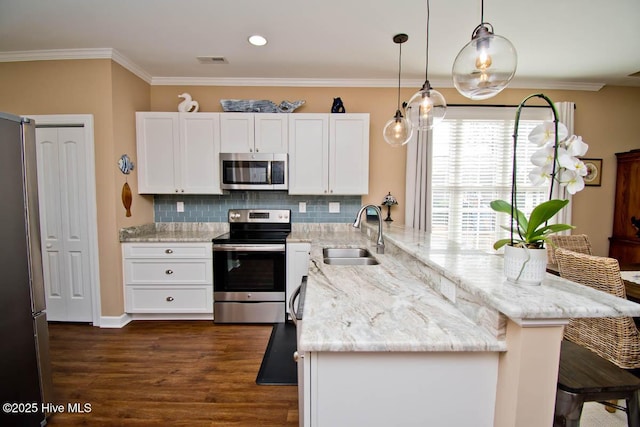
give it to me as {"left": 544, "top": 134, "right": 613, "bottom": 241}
{"left": 407, "top": 0, "right": 447, "bottom": 131}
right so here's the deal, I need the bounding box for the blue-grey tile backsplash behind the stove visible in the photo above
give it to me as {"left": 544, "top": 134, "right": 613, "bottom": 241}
{"left": 154, "top": 191, "right": 362, "bottom": 223}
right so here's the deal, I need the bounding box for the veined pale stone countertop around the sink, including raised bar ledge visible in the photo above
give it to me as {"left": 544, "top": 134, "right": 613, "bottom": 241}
{"left": 288, "top": 224, "right": 640, "bottom": 351}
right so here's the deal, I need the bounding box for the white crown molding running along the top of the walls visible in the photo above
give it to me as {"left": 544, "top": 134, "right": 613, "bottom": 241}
{"left": 0, "top": 48, "right": 605, "bottom": 92}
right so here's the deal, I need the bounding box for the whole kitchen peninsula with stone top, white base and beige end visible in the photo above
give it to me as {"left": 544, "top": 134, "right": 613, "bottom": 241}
{"left": 289, "top": 224, "right": 640, "bottom": 427}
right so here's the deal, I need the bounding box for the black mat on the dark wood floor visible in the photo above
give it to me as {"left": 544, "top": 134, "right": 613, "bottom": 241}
{"left": 256, "top": 322, "right": 298, "bottom": 385}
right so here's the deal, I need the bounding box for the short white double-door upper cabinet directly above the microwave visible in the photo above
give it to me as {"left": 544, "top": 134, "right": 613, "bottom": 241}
{"left": 220, "top": 113, "right": 289, "bottom": 153}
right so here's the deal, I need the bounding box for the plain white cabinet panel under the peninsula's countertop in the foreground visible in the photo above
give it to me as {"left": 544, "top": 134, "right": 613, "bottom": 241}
{"left": 300, "top": 351, "right": 499, "bottom": 427}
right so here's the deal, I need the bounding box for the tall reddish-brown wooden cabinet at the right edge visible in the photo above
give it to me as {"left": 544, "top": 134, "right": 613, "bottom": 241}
{"left": 609, "top": 149, "right": 640, "bottom": 265}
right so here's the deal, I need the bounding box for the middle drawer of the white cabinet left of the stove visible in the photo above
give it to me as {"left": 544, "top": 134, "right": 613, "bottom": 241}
{"left": 124, "top": 259, "right": 213, "bottom": 285}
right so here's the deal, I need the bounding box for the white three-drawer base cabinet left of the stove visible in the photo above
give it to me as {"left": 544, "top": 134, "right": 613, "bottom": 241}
{"left": 122, "top": 242, "right": 213, "bottom": 319}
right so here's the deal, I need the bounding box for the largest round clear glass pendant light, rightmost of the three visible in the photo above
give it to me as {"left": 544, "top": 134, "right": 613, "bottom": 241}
{"left": 452, "top": 0, "right": 518, "bottom": 100}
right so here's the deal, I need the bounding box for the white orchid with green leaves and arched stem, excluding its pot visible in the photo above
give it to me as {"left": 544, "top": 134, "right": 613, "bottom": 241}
{"left": 490, "top": 94, "right": 589, "bottom": 249}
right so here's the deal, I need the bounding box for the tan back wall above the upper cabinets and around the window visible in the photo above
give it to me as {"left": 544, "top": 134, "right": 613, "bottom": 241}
{"left": 151, "top": 86, "right": 640, "bottom": 255}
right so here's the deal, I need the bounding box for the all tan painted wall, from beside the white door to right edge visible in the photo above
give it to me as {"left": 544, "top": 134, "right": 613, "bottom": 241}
{"left": 0, "top": 59, "right": 640, "bottom": 316}
